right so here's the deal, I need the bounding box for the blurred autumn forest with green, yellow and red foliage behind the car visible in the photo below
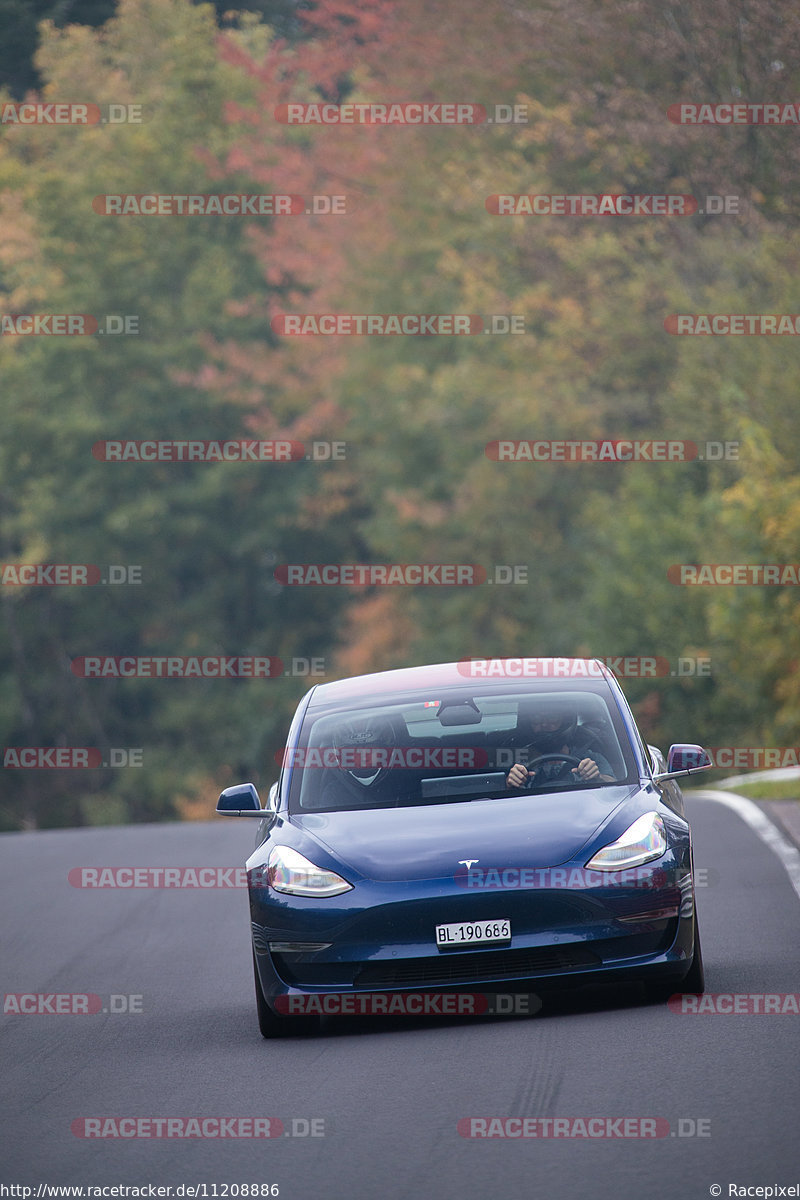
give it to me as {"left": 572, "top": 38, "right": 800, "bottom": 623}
{"left": 0, "top": 0, "right": 800, "bottom": 830}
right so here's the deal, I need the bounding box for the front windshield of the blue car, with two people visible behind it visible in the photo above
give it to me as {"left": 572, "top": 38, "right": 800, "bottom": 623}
{"left": 284, "top": 684, "right": 638, "bottom": 811}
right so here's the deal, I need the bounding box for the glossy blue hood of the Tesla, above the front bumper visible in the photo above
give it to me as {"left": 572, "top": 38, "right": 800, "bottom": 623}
{"left": 290, "top": 785, "right": 639, "bottom": 881}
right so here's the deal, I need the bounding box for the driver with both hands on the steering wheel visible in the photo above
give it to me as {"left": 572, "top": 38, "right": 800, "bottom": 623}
{"left": 506, "top": 701, "right": 614, "bottom": 787}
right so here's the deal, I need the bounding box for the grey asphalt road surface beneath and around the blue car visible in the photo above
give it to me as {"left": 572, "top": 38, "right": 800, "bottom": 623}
{"left": 0, "top": 799, "right": 800, "bottom": 1200}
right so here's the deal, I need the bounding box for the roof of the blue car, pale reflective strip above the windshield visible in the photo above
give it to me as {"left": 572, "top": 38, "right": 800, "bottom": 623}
{"left": 304, "top": 658, "right": 613, "bottom": 707}
